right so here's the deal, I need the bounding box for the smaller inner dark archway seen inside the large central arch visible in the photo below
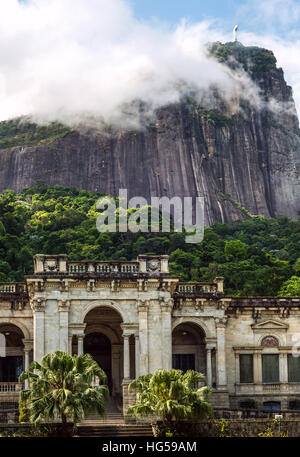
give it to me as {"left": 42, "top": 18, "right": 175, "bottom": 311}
{"left": 84, "top": 332, "right": 113, "bottom": 394}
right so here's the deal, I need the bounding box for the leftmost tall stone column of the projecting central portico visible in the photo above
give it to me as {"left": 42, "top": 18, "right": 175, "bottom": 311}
{"left": 32, "top": 300, "right": 46, "bottom": 362}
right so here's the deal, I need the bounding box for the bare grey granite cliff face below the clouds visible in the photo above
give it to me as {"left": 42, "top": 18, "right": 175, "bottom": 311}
{"left": 0, "top": 41, "right": 300, "bottom": 225}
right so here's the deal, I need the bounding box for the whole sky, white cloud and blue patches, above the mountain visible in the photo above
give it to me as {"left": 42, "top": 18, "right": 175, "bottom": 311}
{"left": 0, "top": 0, "right": 300, "bottom": 123}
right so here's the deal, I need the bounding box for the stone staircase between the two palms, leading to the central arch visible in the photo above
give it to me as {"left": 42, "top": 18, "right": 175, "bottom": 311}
{"left": 77, "top": 399, "right": 153, "bottom": 437}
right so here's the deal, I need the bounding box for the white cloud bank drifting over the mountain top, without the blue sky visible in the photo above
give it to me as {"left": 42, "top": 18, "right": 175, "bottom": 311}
{"left": 0, "top": 0, "right": 300, "bottom": 125}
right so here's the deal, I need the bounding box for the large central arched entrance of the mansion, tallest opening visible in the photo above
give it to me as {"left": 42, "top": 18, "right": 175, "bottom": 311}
{"left": 83, "top": 306, "right": 123, "bottom": 399}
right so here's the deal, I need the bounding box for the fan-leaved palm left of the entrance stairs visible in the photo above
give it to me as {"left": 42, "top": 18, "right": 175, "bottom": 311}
{"left": 19, "top": 351, "right": 109, "bottom": 434}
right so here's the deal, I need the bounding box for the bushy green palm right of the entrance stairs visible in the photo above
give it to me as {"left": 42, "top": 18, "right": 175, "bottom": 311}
{"left": 128, "top": 370, "right": 213, "bottom": 433}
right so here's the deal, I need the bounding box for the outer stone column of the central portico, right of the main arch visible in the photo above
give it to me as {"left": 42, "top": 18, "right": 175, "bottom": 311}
{"left": 160, "top": 300, "right": 174, "bottom": 370}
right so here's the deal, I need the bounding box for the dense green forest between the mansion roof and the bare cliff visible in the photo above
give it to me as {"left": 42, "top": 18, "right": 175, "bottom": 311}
{"left": 0, "top": 183, "right": 300, "bottom": 296}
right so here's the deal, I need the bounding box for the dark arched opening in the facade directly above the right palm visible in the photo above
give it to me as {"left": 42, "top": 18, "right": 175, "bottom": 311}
{"left": 172, "top": 322, "right": 206, "bottom": 375}
